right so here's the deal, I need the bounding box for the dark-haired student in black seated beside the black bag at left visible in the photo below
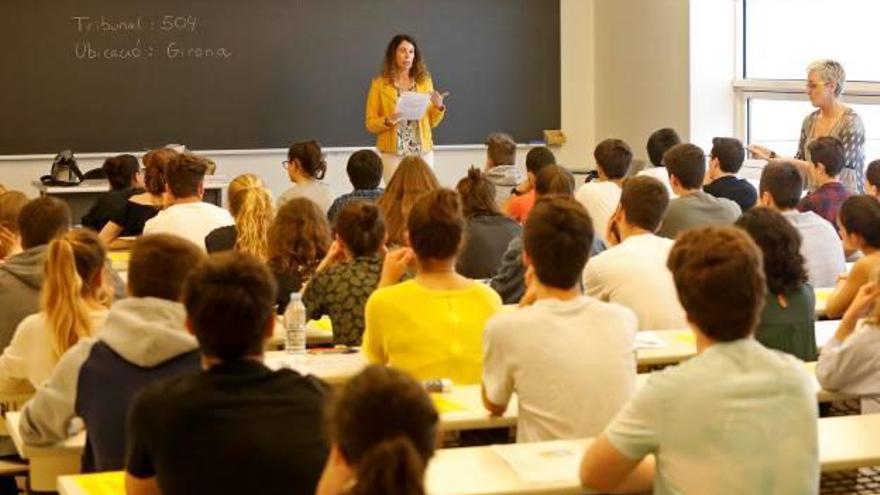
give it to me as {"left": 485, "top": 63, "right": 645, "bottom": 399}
{"left": 82, "top": 155, "right": 143, "bottom": 232}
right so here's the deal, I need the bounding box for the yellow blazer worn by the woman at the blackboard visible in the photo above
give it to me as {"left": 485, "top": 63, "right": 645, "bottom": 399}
{"left": 364, "top": 76, "right": 446, "bottom": 153}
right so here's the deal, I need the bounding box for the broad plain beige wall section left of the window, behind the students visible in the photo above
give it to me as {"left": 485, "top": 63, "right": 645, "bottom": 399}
{"left": 594, "top": 0, "right": 691, "bottom": 165}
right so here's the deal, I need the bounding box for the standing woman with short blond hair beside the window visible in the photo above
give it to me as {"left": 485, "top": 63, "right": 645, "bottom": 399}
{"left": 748, "top": 60, "right": 865, "bottom": 194}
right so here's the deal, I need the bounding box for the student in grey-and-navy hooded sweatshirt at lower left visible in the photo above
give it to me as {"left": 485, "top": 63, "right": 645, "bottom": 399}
{"left": 19, "top": 234, "right": 205, "bottom": 472}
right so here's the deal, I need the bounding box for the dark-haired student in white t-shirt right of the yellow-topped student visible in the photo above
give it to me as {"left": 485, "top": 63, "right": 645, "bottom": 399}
{"left": 483, "top": 195, "right": 637, "bottom": 442}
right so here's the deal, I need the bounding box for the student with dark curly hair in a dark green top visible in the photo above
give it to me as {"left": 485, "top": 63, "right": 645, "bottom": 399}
{"left": 735, "top": 207, "right": 819, "bottom": 361}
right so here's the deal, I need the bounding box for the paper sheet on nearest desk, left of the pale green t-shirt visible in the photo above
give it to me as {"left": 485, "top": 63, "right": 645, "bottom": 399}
{"left": 490, "top": 440, "right": 583, "bottom": 483}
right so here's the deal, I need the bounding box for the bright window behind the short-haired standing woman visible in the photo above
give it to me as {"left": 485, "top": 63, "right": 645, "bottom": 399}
{"left": 734, "top": 0, "right": 880, "bottom": 161}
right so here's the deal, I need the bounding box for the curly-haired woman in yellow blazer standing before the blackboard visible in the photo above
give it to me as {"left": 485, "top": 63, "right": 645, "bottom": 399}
{"left": 365, "top": 34, "right": 448, "bottom": 184}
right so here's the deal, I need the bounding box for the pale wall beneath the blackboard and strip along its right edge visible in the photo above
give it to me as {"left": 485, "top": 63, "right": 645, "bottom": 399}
{"left": 0, "top": 0, "right": 594, "bottom": 200}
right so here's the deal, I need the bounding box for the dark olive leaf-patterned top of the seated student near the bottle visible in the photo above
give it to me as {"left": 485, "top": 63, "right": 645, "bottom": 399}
{"left": 302, "top": 256, "right": 382, "bottom": 346}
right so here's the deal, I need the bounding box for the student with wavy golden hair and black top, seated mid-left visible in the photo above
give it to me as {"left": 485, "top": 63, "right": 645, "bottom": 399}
{"left": 205, "top": 174, "right": 275, "bottom": 262}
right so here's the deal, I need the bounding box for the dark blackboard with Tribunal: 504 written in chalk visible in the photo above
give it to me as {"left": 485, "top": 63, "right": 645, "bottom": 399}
{"left": 0, "top": 0, "right": 560, "bottom": 155}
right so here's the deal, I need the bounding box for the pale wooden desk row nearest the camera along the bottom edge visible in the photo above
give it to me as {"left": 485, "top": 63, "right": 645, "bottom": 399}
{"left": 58, "top": 414, "right": 880, "bottom": 495}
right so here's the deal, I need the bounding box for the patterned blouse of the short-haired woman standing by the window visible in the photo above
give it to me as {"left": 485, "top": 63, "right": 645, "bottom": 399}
{"left": 794, "top": 108, "right": 865, "bottom": 194}
